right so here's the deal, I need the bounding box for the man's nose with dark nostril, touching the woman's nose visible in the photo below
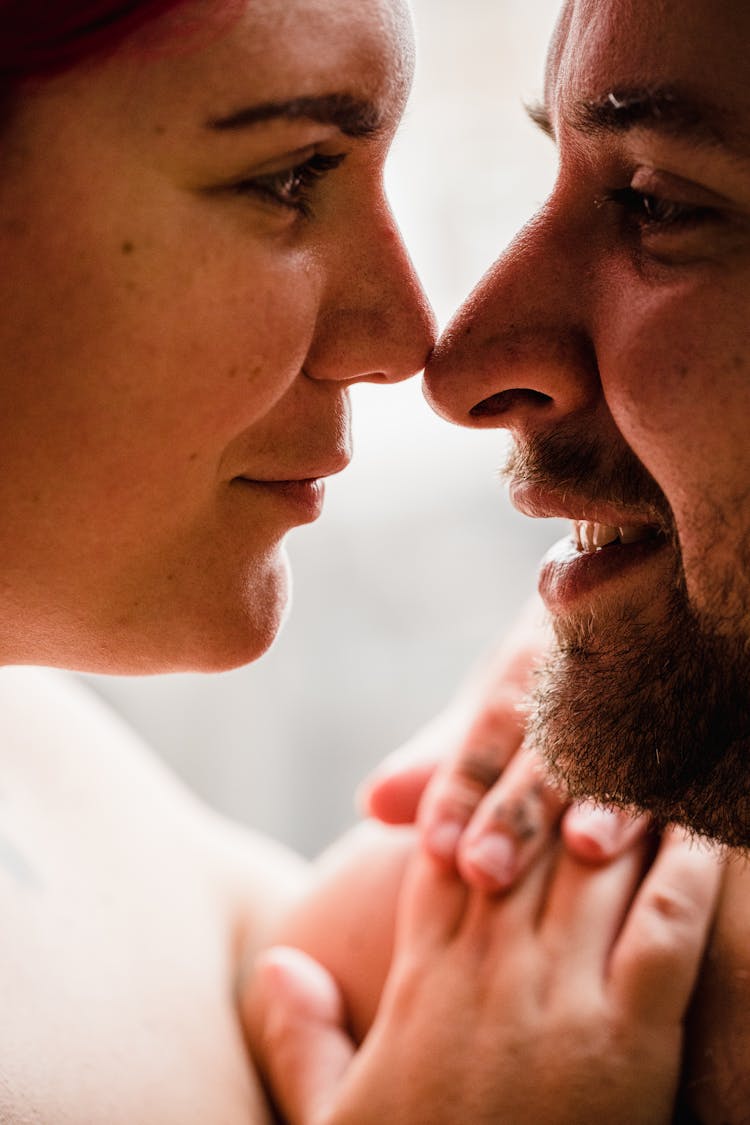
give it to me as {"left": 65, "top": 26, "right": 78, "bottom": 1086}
{"left": 425, "top": 215, "right": 599, "bottom": 438}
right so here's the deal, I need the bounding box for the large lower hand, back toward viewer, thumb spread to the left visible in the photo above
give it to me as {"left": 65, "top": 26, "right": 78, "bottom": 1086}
{"left": 253, "top": 834, "right": 720, "bottom": 1125}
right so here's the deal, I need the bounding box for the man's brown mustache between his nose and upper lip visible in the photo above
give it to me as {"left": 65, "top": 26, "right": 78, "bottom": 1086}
{"left": 500, "top": 429, "right": 676, "bottom": 537}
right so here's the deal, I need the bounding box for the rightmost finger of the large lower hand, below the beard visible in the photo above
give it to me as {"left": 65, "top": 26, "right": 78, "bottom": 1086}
{"left": 609, "top": 829, "right": 723, "bottom": 1024}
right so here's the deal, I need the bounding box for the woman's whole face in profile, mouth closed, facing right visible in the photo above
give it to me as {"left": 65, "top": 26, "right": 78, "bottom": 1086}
{"left": 0, "top": 0, "right": 433, "bottom": 672}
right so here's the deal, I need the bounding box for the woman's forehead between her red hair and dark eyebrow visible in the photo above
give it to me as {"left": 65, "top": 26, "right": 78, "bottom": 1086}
{"left": 88, "top": 0, "right": 414, "bottom": 138}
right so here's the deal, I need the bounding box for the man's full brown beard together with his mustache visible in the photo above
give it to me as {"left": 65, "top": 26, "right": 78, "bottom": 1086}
{"left": 508, "top": 425, "right": 750, "bottom": 848}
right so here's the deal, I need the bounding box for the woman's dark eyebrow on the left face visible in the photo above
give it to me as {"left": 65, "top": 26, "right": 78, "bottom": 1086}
{"left": 206, "top": 93, "right": 383, "bottom": 137}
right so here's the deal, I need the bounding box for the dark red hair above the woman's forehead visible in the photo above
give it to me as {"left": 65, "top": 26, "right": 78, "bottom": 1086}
{"left": 0, "top": 0, "right": 201, "bottom": 84}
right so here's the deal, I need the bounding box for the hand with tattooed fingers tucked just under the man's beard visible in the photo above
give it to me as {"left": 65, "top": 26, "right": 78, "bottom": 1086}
{"left": 360, "top": 602, "right": 644, "bottom": 890}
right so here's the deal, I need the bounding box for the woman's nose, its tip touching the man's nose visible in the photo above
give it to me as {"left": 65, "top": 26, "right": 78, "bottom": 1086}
{"left": 306, "top": 204, "right": 437, "bottom": 383}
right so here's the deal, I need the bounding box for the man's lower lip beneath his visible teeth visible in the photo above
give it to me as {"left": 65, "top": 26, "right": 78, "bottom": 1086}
{"left": 539, "top": 529, "right": 667, "bottom": 614}
